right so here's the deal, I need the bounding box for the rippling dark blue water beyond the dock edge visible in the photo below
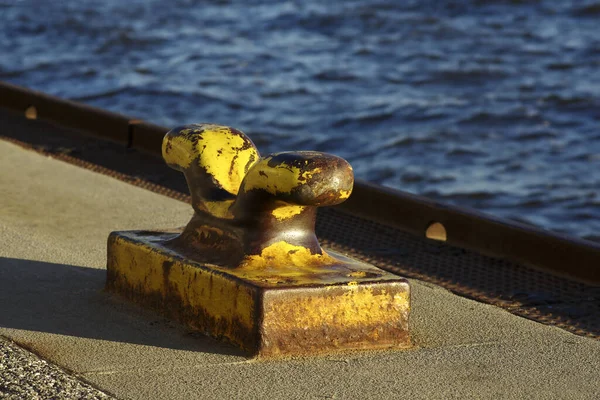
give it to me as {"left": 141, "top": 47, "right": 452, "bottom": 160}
{"left": 0, "top": 0, "right": 600, "bottom": 240}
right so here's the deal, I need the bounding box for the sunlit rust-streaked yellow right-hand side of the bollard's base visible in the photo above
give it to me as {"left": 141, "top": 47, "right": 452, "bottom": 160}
{"left": 261, "top": 282, "right": 410, "bottom": 356}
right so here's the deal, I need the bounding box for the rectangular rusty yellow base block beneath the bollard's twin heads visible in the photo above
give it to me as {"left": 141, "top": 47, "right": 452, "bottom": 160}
{"left": 106, "top": 231, "right": 410, "bottom": 357}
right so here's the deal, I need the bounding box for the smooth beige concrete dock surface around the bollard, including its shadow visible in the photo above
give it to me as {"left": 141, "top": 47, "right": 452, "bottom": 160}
{"left": 0, "top": 141, "right": 600, "bottom": 399}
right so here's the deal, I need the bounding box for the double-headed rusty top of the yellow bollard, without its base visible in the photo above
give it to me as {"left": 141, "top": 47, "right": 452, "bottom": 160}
{"left": 162, "top": 124, "right": 354, "bottom": 266}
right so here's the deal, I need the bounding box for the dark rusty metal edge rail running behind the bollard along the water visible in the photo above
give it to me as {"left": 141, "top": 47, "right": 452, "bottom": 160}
{"left": 0, "top": 82, "right": 600, "bottom": 284}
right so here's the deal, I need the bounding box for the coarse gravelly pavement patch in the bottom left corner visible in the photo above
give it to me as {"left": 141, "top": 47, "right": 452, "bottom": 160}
{"left": 0, "top": 338, "right": 113, "bottom": 400}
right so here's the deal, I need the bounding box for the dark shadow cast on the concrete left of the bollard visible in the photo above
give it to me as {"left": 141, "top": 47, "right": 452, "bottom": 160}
{"left": 0, "top": 257, "right": 247, "bottom": 356}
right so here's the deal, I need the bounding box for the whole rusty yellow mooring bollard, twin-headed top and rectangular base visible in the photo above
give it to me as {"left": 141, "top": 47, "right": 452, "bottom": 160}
{"left": 106, "top": 124, "right": 410, "bottom": 357}
